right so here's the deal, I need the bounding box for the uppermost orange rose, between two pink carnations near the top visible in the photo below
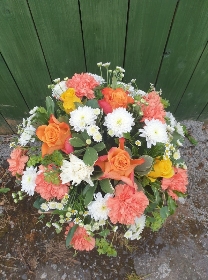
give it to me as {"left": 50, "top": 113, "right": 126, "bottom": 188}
{"left": 98, "top": 88, "right": 134, "bottom": 114}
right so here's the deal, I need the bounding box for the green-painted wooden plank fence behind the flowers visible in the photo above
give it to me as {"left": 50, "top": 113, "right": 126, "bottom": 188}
{"left": 0, "top": 0, "right": 208, "bottom": 134}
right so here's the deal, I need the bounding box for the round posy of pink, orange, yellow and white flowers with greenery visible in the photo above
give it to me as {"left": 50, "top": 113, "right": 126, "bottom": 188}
{"left": 8, "top": 63, "right": 188, "bottom": 256}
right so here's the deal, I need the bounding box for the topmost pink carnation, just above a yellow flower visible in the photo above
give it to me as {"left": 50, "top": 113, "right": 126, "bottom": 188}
{"left": 66, "top": 73, "right": 99, "bottom": 99}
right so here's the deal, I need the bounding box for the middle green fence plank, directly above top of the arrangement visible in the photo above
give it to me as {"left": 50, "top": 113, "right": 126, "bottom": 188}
{"left": 80, "top": 0, "right": 128, "bottom": 73}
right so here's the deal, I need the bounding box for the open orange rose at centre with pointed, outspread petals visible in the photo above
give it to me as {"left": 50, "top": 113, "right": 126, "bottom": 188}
{"left": 95, "top": 138, "right": 144, "bottom": 187}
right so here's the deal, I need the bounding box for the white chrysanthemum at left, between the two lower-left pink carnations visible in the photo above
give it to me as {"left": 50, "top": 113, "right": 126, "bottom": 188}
{"left": 21, "top": 166, "right": 37, "bottom": 195}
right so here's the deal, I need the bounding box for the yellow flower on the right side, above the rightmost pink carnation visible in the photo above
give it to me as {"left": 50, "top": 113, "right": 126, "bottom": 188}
{"left": 148, "top": 159, "right": 174, "bottom": 182}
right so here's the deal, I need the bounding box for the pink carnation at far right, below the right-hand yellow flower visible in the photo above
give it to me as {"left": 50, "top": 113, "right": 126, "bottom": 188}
{"left": 161, "top": 167, "right": 188, "bottom": 200}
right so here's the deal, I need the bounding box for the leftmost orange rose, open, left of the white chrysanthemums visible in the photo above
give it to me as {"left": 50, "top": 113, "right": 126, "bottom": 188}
{"left": 36, "top": 115, "right": 71, "bottom": 157}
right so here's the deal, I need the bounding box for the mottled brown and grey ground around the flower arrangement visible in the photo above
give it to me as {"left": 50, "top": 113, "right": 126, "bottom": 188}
{"left": 0, "top": 121, "right": 208, "bottom": 280}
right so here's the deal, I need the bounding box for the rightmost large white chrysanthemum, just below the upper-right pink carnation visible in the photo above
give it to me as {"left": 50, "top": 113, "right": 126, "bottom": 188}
{"left": 139, "top": 119, "right": 168, "bottom": 148}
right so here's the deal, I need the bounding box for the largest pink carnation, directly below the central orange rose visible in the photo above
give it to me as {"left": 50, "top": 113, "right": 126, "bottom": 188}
{"left": 107, "top": 184, "right": 149, "bottom": 225}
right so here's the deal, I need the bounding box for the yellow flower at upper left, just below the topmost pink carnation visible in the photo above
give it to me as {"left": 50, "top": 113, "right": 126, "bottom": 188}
{"left": 60, "top": 88, "right": 81, "bottom": 114}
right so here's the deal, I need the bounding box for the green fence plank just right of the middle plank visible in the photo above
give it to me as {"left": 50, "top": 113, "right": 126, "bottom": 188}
{"left": 125, "top": 0, "right": 177, "bottom": 90}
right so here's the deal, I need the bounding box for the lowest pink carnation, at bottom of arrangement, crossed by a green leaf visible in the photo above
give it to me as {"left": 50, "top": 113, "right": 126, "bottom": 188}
{"left": 65, "top": 222, "right": 95, "bottom": 251}
